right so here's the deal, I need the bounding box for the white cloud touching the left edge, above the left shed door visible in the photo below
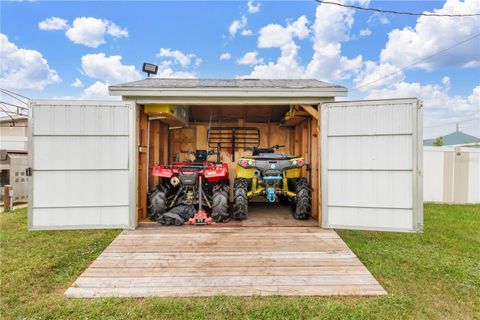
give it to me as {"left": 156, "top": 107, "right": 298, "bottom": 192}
{"left": 0, "top": 33, "right": 61, "bottom": 90}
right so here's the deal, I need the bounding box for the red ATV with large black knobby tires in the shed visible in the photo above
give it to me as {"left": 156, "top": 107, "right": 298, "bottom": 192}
{"left": 148, "top": 150, "right": 230, "bottom": 222}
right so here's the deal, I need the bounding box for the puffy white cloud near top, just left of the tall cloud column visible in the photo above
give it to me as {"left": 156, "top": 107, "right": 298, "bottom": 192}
{"left": 258, "top": 16, "right": 310, "bottom": 48}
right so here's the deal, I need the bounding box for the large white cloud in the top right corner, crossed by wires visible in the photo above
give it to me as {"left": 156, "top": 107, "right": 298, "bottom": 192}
{"left": 380, "top": 0, "right": 480, "bottom": 70}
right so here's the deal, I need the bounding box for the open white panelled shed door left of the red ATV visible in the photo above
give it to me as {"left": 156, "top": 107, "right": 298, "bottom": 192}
{"left": 28, "top": 100, "right": 135, "bottom": 230}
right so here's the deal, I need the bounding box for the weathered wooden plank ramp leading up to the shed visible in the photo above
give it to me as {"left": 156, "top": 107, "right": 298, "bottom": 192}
{"left": 65, "top": 226, "right": 386, "bottom": 298}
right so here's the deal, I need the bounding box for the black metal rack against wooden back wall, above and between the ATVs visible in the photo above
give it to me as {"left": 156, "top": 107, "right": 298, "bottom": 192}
{"left": 208, "top": 127, "right": 260, "bottom": 161}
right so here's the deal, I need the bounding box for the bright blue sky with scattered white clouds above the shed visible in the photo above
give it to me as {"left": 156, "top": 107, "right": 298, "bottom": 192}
{"left": 0, "top": 0, "right": 480, "bottom": 137}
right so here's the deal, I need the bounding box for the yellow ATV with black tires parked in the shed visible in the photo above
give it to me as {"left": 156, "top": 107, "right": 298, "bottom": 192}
{"left": 233, "top": 145, "right": 311, "bottom": 220}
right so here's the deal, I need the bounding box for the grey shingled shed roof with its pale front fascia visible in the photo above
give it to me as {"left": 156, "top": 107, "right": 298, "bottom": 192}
{"left": 109, "top": 78, "right": 347, "bottom": 102}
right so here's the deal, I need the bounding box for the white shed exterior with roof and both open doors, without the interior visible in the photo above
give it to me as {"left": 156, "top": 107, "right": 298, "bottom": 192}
{"left": 29, "top": 79, "right": 423, "bottom": 231}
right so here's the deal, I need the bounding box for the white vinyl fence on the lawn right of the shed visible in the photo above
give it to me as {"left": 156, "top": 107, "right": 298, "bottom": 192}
{"left": 423, "top": 147, "right": 480, "bottom": 203}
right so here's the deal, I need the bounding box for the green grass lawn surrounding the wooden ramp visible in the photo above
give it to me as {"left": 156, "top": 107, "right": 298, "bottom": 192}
{"left": 0, "top": 204, "right": 480, "bottom": 319}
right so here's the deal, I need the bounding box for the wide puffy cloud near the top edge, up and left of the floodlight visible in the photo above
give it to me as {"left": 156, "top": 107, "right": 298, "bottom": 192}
{"left": 65, "top": 17, "right": 128, "bottom": 48}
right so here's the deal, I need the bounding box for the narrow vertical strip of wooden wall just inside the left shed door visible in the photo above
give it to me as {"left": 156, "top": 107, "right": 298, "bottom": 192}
{"left": 137, "top": 106, "right": 148, "bottom": 221}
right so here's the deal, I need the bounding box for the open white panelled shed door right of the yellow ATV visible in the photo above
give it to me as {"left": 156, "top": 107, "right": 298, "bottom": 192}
{"left": 321, "top": 99, "right": 423, "bottom": 232}
